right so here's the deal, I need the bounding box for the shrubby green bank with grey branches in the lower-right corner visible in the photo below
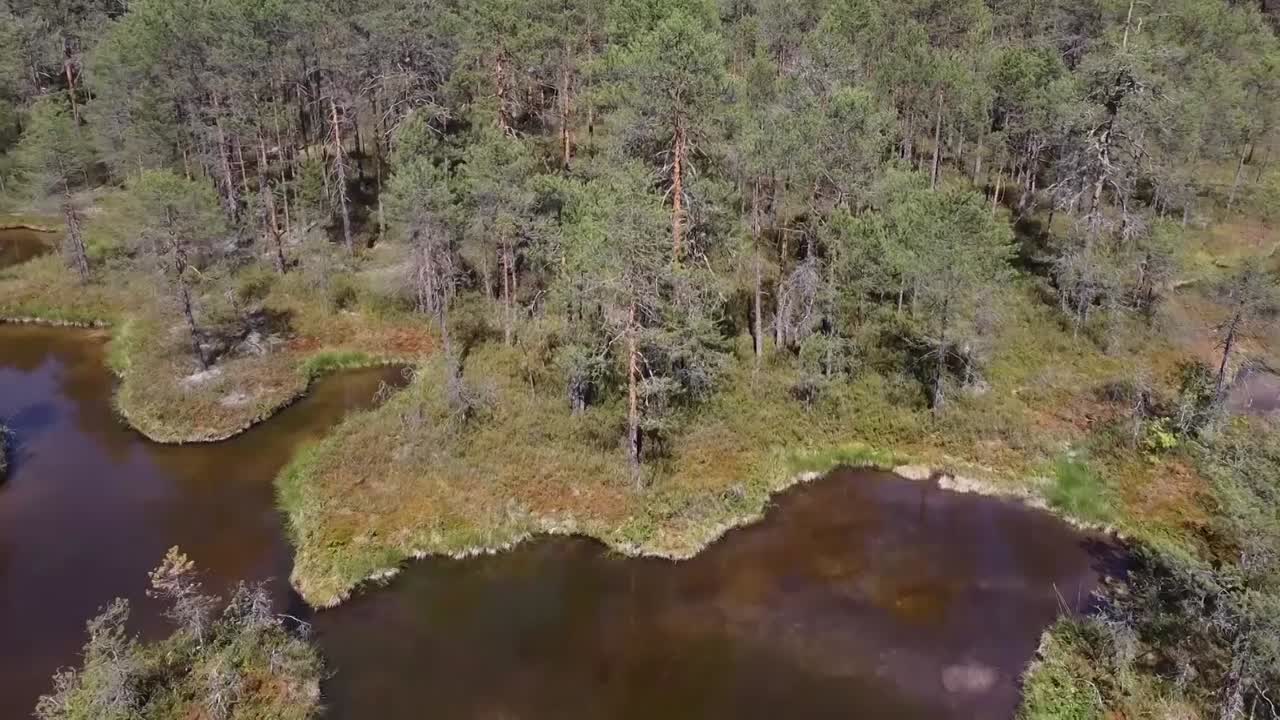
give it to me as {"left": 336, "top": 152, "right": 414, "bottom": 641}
{"left": 1019, "top": 420, "right": 1280, "bottom": 720}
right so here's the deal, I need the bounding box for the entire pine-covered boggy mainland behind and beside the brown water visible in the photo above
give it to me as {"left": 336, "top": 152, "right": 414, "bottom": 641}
{"left": 0, "top": 0, "right": 1280, "bottom": 717}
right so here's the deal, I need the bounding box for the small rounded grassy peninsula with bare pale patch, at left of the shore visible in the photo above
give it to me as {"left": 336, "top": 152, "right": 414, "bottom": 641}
{"left": 0, "top": 211, "right": 433, "bottom": 442}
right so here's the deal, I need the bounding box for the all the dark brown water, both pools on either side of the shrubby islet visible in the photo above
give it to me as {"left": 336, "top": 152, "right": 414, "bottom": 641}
{"left": 0, "top": 327, "right": 1107, "bottom": 720}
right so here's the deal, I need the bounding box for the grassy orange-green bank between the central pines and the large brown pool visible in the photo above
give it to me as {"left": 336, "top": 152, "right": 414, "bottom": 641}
{"left": 279, "top": 275, "right": 1198, "bottom": 605}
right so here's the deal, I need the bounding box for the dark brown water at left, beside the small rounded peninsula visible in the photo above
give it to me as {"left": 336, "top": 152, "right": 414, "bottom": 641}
{"left": 0, "top": 325, "right": 397, "bottom": 720}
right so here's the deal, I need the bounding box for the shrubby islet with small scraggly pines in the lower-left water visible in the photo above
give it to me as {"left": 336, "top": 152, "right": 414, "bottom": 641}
{"left": 36, "top": 548, "right": 323, "bottom": 720}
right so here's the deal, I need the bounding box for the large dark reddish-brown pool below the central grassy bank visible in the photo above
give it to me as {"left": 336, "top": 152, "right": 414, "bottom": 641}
{"left": 315, "top": 471, "right": 1106, "bottom": 720}
